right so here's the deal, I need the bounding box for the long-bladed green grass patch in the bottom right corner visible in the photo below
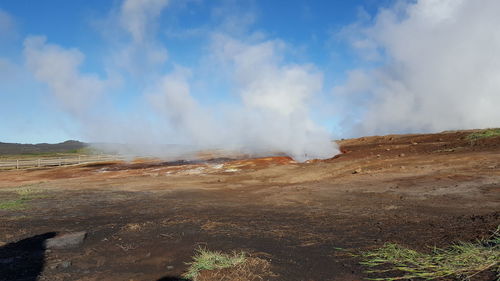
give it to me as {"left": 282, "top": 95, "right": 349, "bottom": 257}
{"left": 361, "top": 225, "right": 500, "bottom": 281}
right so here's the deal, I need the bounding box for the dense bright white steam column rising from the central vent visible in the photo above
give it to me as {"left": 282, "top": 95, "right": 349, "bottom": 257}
{"left": 212, "top": 34, "right": 339, "bottom": 161}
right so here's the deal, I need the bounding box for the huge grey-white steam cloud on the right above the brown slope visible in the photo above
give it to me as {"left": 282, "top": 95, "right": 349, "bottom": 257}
{"left": 333, "top": 0, "right": 500, "bottom": 135}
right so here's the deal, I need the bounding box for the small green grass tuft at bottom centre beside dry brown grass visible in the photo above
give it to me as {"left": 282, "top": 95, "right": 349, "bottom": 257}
{"left": 182, "top": 248, "right": 247, "bottom": 281}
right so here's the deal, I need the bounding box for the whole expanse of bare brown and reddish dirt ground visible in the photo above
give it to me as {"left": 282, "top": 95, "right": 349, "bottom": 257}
{"left": 0, "top": 131, "right": 500, "bottom": 281}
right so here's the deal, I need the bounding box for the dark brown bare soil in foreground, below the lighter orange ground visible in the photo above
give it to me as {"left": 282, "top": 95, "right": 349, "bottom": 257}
{"left": 0, "top": 186, "right": 500, "bottom": 281}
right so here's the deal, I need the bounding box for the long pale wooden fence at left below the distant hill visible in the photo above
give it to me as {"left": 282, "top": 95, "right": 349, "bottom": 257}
{"left": 0, "top": 155, "right": 125, "bottom": 169}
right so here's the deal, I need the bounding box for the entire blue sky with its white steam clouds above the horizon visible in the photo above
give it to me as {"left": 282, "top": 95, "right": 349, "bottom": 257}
{"left": 0, "top": 0, "right": 499, "bottom": 155}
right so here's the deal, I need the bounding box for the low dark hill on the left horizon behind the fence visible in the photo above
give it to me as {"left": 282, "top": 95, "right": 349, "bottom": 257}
{"left": 0, "top": 140, "right": 89, "bottom": 155}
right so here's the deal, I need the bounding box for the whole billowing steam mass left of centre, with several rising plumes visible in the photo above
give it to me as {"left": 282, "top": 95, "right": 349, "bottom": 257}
{"left": 24, "top": 0, "right": 339, "bottom": 161}
